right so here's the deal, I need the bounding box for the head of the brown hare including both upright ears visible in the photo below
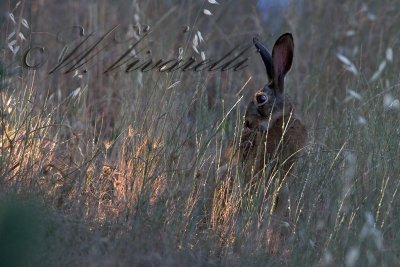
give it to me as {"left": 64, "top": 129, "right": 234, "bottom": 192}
{"left": 245, "top": 33, "right": 294, "bottom": 130}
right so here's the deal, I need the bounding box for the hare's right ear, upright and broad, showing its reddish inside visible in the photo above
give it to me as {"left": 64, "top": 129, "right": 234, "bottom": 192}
{"left": 272, "top": 33, "right": 294, "bottom": 93}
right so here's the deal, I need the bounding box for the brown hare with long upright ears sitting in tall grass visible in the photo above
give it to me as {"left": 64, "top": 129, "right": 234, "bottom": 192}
{"left": 239, "top": 33, "right": 307, "bottom": 188}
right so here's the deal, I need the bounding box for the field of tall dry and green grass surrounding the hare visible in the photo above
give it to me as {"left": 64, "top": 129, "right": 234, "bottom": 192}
{"left": 0, "top": 0, "right": 400, "bottom": 266}
